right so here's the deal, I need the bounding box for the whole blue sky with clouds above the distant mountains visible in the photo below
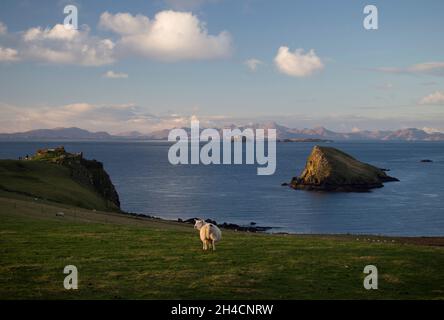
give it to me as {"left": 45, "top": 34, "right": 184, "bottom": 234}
{"left": 0, "top": 0, "right": 444, "bottom": 133}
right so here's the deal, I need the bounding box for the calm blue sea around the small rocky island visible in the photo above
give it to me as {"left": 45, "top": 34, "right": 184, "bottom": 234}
{"left": 0, "top": 141, "right": 444, "bottom": 236}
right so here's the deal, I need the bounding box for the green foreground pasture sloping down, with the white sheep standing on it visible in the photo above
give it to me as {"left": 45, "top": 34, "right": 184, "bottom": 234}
{"left": 0, "top": 198, "right": 444, "bottom": 299}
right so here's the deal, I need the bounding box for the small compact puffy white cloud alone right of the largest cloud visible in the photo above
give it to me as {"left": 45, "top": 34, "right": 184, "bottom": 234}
{"left": 274, "top": 47, "right": 324, "bottom": 77}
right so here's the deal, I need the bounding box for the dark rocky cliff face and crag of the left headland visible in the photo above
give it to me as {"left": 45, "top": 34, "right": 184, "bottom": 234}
{"left": 29, "top": 147, "right": 120, "bottom": 208}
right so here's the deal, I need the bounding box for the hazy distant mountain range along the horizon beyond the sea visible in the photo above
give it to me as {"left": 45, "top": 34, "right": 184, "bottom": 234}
{"left": 0, "top": 122, "right": 444, "bottom": 141}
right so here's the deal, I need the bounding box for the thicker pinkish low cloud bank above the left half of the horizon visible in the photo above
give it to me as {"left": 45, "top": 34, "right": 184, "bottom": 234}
{"left": 0, "top": 103, "right": 213, "bottom": 134}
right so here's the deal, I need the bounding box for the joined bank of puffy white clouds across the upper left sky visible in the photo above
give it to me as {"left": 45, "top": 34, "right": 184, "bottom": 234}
{"left": 0, "top": 10, "right": 232, "bottom": 66}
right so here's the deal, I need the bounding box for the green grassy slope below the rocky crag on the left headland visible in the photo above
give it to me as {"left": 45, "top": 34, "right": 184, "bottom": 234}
{"left": 0, "top": 160, "right": 116, "bottom": 210}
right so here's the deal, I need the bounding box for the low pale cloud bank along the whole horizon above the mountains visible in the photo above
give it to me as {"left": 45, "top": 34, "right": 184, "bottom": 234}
{"left": 0, "top": 103, "right": 444, "bottom": 134}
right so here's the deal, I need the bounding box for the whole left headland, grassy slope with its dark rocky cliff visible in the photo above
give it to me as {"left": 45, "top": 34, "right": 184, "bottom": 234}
{"left": 0, "top": 147, "right": 121, "bottom": 212}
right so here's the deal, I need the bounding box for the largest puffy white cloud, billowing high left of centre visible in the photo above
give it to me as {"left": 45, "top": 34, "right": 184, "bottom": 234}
{"left": 99, "top": 11, "right": 232, "bottom": 61}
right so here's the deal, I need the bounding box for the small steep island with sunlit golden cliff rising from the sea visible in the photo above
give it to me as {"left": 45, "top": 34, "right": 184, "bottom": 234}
{"left": 290, "top": 146, "right": 399, "bottom": 191}
